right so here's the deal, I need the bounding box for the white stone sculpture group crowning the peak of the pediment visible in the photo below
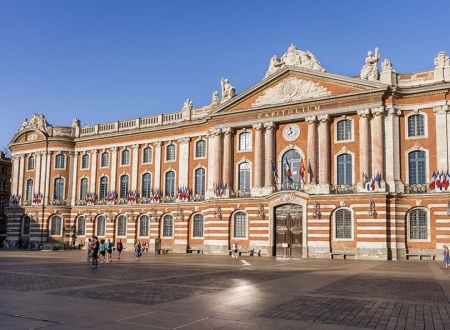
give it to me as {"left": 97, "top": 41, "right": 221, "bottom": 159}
{"left": 265, "top": 44, "right": 325, "bottom": 77}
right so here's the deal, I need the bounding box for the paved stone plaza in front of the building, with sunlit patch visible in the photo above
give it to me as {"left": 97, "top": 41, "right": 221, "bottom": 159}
{"left": 0, "top": 251, "right": 450, "bottom": 330}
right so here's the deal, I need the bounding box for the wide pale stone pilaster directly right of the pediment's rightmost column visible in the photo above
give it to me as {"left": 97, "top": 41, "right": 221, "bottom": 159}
{"left": 384, "top": 106, "right": 403, "bottom": 193}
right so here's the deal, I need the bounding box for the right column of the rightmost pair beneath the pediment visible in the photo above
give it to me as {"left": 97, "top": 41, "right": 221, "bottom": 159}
{"left": 371, "top": 106, "right": 384, "bottom": 179}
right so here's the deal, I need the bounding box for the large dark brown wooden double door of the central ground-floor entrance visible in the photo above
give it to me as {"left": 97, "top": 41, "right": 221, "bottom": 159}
{"left": 273, "top": 204, "right": 303, "bottom": 258}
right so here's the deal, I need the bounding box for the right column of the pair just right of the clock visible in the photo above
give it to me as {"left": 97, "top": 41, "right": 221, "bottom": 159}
{"left": 318, "top": 115, "right": 330, "bottom": 193}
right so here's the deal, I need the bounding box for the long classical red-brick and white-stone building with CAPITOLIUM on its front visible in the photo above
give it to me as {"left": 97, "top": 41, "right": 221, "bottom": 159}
{"left": 7, "top": 45, "right": 450, "bottom": 259}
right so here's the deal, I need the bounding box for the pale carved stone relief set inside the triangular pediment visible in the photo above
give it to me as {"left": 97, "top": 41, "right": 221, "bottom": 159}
{"left": 252, "top": 77, "right": 331, "bottom": 107}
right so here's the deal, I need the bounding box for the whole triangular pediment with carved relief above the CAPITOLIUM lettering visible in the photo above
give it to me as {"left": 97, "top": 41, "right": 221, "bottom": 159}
{"left": 211, "top": 67, "right": 387, "bottom": 115}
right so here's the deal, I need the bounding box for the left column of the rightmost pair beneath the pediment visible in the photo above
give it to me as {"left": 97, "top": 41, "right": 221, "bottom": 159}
{"left": 358, "top": 109, "right": 371, "bottom": 187}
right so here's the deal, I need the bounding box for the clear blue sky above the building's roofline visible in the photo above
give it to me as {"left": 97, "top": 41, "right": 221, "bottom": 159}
{"left": 0, "top": 0, "right": 450, "bottom": 148}
